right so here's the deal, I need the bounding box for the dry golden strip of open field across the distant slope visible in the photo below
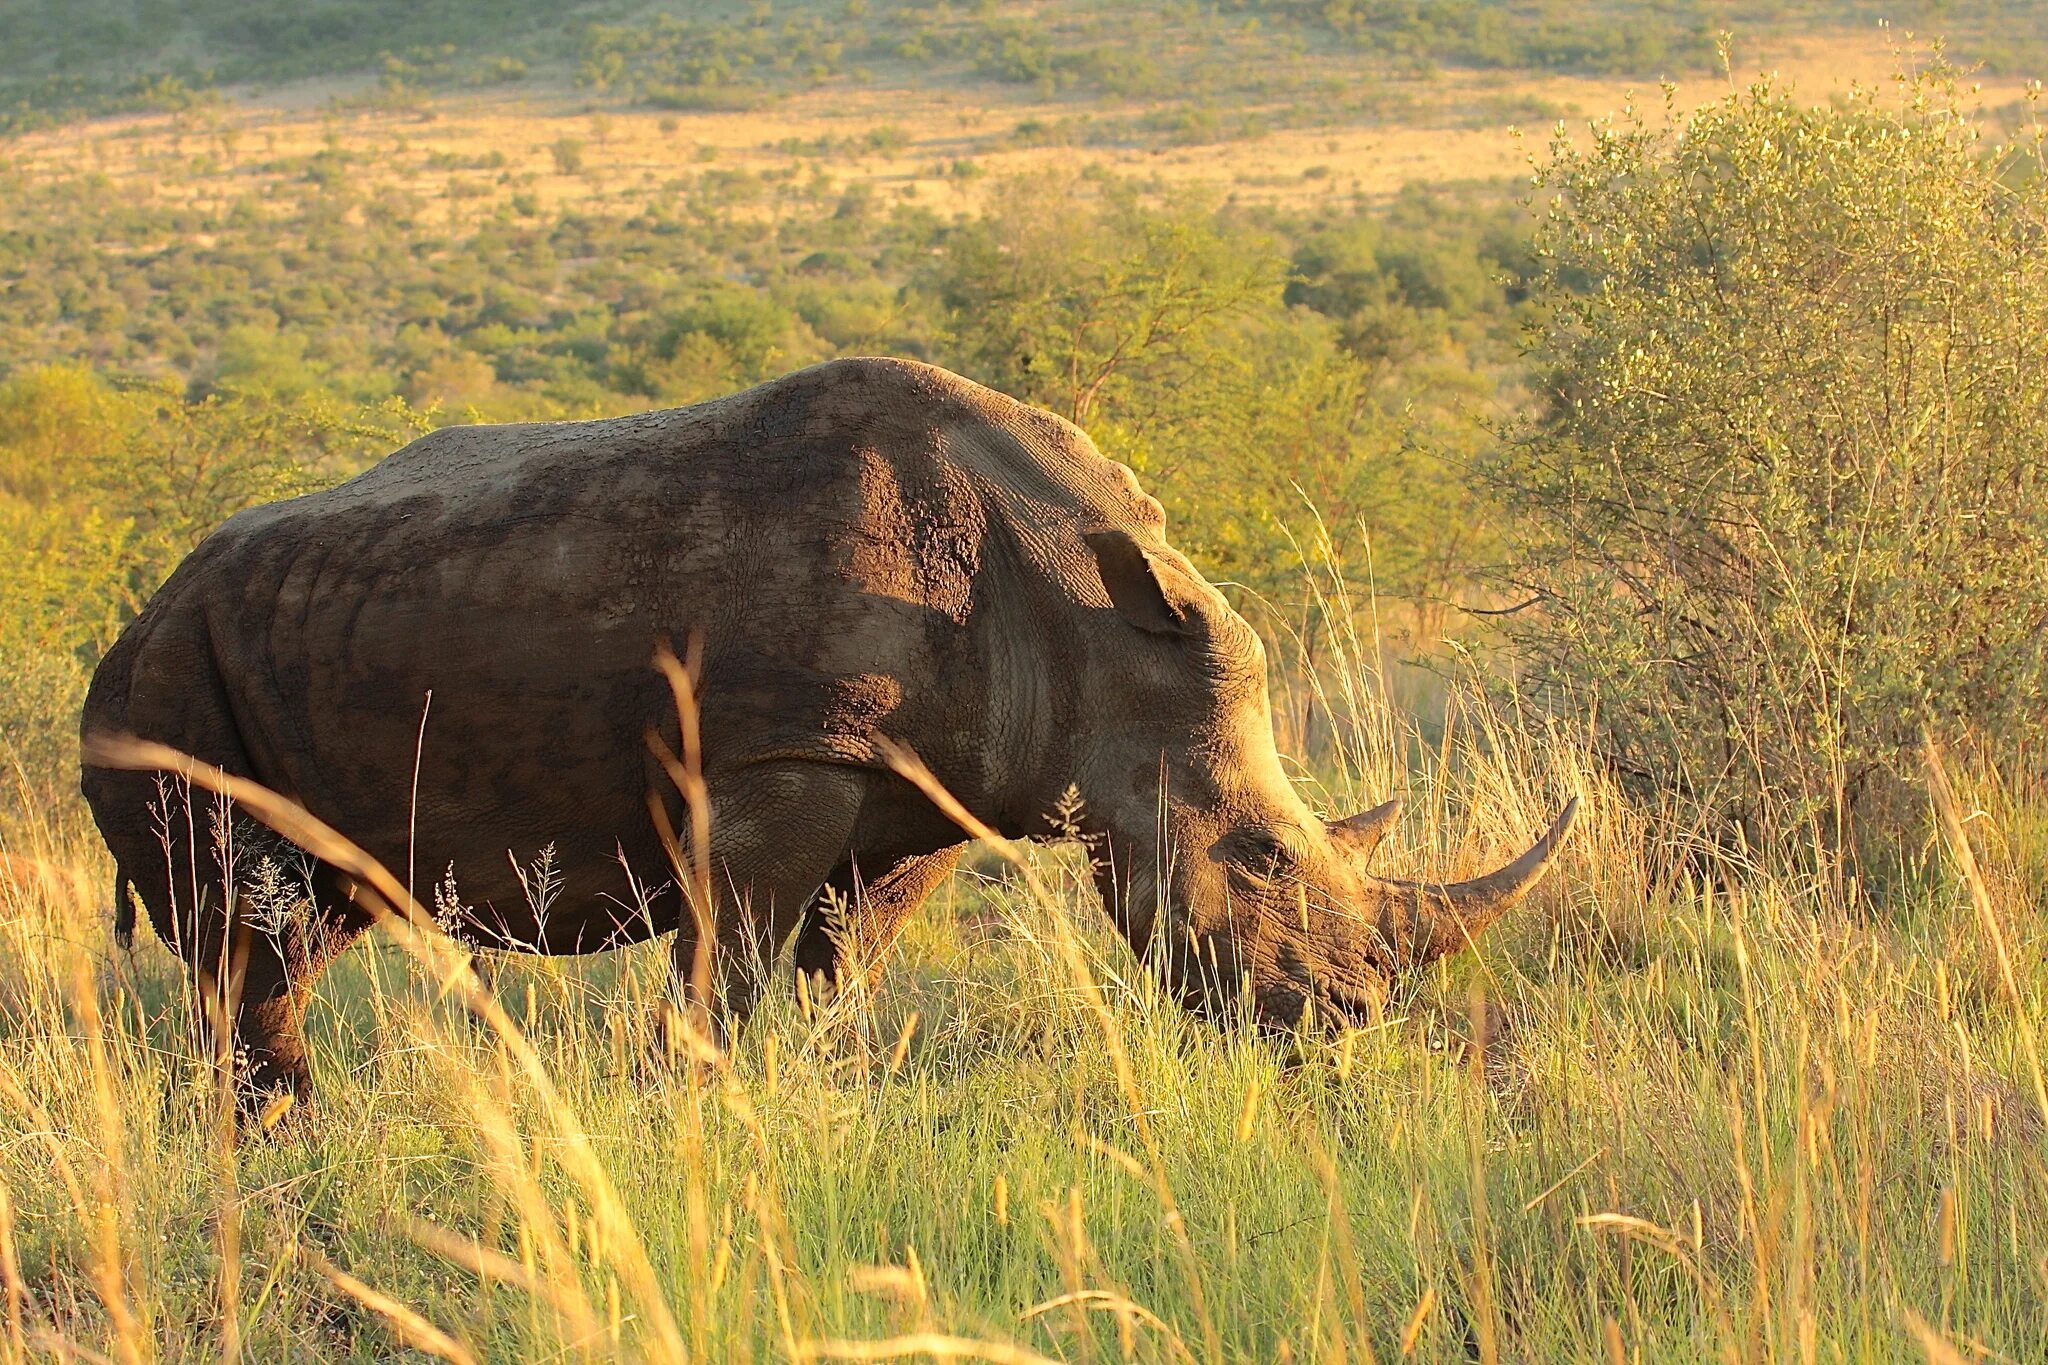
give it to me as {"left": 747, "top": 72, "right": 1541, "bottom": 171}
{"left": 12, "top": 29, "right": 2028, "bottom": 223}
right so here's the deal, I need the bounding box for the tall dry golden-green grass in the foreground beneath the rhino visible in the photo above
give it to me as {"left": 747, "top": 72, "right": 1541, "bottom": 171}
{"left": 0, "top": 604, "right": 2048, "bottom": 1363}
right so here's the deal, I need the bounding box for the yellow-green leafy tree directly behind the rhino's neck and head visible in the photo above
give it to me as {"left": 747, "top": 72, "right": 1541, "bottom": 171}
{"left": 918, "top": 180, "right": 1520, "bottom": 616}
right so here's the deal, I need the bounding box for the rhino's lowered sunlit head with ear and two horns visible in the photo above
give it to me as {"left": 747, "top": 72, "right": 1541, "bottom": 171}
{"left": 1081, "top": 530, "right": 1579, "bottom": 1027}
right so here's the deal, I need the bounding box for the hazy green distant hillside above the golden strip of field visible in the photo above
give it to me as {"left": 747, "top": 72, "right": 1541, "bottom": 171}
{"left": 0, "top": 0, "right": 2048, "bottom": 129}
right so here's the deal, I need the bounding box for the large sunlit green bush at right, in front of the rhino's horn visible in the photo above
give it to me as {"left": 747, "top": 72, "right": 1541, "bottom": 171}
{"left": 1489, "top": 72, "right": 2048, "bottom": 853}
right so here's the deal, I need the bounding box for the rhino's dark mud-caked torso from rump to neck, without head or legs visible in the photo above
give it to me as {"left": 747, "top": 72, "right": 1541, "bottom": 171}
{"left": 88, "top": 360, "right": 1157, "bottom": 945}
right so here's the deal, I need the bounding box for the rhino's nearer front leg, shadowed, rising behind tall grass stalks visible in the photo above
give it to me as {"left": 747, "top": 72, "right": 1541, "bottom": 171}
{"left": 657, "top": 761, "right": 866, "bottom": 1052}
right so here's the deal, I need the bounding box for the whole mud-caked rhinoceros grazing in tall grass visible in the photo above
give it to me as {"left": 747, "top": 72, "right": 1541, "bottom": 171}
{"left": 82, "top": 358, "right": 1577, "bottom": 1097}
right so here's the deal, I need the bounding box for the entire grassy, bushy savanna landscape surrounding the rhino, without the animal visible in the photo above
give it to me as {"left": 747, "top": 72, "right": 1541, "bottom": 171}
{"left": 0, "top": 0, "right": 2048, "bottom": 1365}
